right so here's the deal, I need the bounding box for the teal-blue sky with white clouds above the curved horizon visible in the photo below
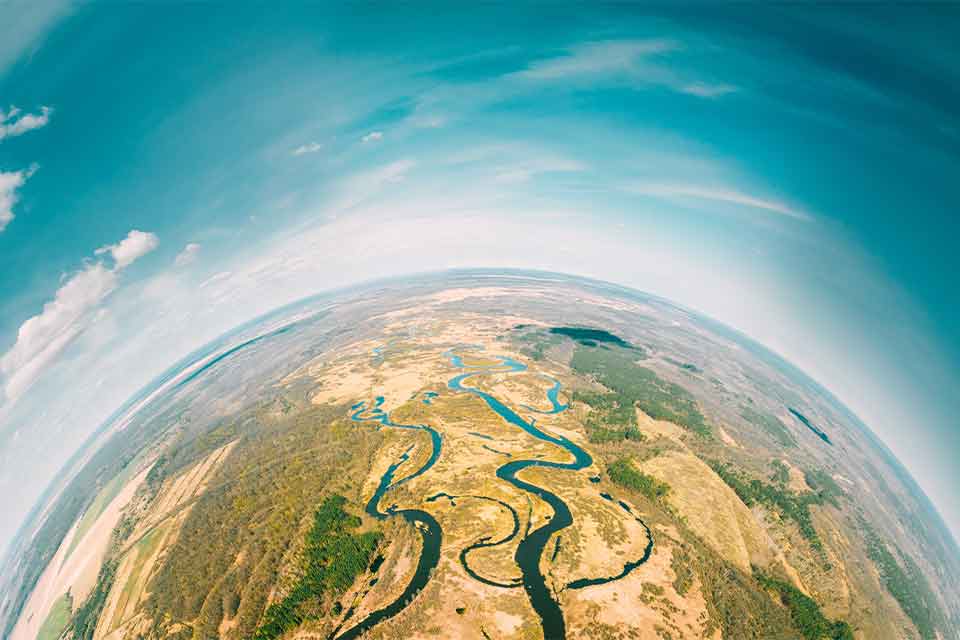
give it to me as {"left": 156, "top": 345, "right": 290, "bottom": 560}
{"left": 0, "top": 1, "right": 960, "bottom": 552}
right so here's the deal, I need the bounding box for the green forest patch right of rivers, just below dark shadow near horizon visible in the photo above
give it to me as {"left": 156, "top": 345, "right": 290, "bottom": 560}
{"left": 570, "top": 346, "right": 711, "bottom": 437}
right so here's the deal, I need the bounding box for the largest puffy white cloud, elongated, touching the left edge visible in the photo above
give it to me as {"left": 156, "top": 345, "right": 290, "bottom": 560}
{"left": 0, "top": 231, "right": 157, "bottom": 402}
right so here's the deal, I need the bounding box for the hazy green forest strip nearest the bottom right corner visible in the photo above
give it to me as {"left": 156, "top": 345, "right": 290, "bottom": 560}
{"left": 862, "top": 523, "right": 944, "bottom": 640}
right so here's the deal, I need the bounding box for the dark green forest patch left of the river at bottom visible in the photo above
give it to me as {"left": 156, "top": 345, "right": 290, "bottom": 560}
{"left": 253, "top": 495, "right": 381, "bottom": 640}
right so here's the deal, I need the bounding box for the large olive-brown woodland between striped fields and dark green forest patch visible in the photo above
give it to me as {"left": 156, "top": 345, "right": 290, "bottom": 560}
{"left": 144, "top": 405, "right": 385, "bottom": 639}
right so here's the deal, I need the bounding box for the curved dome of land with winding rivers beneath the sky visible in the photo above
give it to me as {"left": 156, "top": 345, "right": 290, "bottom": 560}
{"left": 0, "top": 272, "right": 960, "bottom": 640}
